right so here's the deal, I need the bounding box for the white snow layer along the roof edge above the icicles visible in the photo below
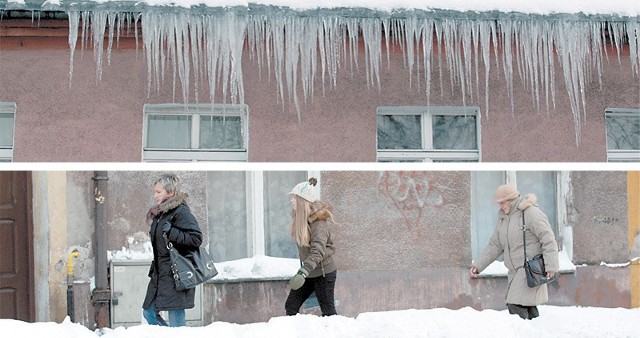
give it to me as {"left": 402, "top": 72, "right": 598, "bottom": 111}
{"left": 0, "top": 0, "right": 640, "bottom": 20}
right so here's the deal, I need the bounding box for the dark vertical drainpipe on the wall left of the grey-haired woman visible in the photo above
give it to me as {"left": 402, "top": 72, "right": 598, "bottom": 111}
{"left": 91, "top": 171, "right": 111, "bottom": 328}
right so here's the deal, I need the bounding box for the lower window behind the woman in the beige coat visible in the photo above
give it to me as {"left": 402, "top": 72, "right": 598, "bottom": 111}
{"left": 471, "top": 171, "right": 571, "bottom": 260}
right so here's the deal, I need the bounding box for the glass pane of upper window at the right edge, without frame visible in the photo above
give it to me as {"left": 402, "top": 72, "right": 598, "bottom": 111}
{"left": 607, "top": 116, "right": 640, "bottom": 150}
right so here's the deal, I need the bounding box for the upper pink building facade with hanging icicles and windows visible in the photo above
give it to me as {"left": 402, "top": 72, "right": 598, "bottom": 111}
{"left": 0, "top": 1, "right": 640, "bottom": 162}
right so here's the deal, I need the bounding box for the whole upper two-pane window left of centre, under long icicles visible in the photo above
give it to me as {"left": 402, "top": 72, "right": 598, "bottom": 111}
{"left": 142, "top": 104, "right": 248, "bottom": 162}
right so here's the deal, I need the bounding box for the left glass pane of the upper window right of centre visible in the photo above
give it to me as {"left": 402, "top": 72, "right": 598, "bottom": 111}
{"left": 377, "top": 115, "right": 422, "bottom": 149}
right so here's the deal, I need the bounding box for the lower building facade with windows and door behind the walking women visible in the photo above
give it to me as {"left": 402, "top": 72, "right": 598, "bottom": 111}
{"left": 0, "top": 171, "right": 640, "bottom": 327}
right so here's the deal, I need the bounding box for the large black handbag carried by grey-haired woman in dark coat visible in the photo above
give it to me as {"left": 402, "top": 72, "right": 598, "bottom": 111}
{"left": 162, "top": 233, "right": 218, "bottom": 291}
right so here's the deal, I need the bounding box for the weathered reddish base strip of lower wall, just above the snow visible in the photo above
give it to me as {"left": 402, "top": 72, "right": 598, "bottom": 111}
{"left": 203, "top": 266, "right": 631, "bottom": 324}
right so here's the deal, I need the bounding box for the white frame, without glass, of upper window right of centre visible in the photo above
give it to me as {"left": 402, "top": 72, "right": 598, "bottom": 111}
{"left": 376, "top": 106, "right": 482, "bottom": 162}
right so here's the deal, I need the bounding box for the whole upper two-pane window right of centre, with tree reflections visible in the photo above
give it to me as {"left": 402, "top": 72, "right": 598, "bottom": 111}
{"left": 377, "top": 106, "right": 480, "bottom": 162}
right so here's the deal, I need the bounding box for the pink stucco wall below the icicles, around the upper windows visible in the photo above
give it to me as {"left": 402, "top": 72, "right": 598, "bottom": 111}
{"left": 0, "top": 23, "right": 640, "bottom": 162}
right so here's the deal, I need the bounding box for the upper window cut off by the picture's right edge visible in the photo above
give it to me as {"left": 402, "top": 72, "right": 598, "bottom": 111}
{"left": 605, "top": 108, "right": 640, "bottom": 162}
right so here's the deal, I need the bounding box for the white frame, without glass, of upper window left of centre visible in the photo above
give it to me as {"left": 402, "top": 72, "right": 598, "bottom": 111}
{"left": 142, "top": 104, "right": 249, "bottom": 162}
